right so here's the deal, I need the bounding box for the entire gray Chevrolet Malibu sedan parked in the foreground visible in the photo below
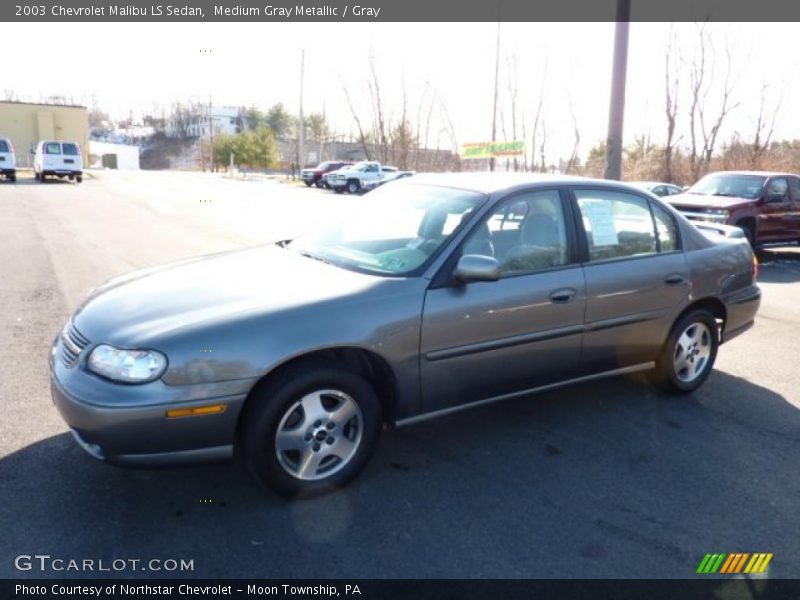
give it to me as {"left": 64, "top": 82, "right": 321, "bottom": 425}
{"left": 51, "top": 174, "right": 760, "bottom": 495}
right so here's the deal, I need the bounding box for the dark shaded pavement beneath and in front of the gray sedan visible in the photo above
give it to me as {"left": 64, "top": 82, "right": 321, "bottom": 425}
{"left": 0, "top": 371, "right": 800, "bottom": 584}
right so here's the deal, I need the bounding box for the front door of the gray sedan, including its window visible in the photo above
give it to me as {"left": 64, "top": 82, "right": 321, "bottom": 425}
{"left": 420, "top": 189, "right": 585, "bottom": 412}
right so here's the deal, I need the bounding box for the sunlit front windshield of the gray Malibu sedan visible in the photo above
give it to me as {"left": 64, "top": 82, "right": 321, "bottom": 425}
{"left": 288, "top": 183, "right": 486, "bottom": 275}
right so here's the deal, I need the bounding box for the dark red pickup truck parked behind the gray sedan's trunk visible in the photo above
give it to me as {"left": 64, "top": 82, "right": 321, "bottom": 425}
{"left": 669, "top": 171, "right": 800, "bottom": 247}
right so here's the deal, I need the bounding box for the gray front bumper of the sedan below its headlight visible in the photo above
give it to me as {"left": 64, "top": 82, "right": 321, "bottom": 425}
{"left": 50, "top": 341, "right": 250, "bottom": 466}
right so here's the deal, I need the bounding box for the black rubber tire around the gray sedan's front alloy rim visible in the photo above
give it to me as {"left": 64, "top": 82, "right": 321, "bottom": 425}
{"left": 240, "top": 360, "right": 382, "bottom": 498}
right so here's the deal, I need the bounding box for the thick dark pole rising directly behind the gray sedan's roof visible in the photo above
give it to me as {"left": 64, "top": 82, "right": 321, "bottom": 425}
{"left": 604, "top": 0, "right": 631, "bottom": 181}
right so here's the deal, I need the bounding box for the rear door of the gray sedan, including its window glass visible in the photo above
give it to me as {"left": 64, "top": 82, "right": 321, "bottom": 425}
{"left": 573, "top": 186, "right": 689, "bottom": 374}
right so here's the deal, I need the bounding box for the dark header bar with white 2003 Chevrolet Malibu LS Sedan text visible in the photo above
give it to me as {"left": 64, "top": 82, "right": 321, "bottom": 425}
{"left": 0, "top": 0, "right": 800, "bottom": 22}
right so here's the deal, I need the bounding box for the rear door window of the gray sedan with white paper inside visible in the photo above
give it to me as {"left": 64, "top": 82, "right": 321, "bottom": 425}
{"left": 575, "top": 190, "right": 658, "bottom": 262}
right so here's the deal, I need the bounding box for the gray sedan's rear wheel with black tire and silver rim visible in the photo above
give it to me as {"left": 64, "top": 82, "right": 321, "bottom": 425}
{"left": 650, "top": 309, "right": 719, "bottom": 394}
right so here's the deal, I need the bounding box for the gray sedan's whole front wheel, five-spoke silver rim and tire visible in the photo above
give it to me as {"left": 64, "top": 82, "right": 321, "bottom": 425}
{"left": 241, "top": 361, "right": 382, "bottom": 497}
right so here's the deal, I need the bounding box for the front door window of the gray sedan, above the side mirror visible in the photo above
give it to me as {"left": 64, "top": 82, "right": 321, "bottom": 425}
{"left": 462, "top": 190, "right": 569, "bottom": 276}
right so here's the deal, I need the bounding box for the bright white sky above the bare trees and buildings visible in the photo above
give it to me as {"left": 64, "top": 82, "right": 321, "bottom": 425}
{"left": 2, "top": 23, "right": 800, "bottom": 161}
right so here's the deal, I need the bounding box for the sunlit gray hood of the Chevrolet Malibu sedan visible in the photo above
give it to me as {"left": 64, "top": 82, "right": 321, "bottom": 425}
{"left": 74, "top": 245, "right": 385, "bottom": 347}
